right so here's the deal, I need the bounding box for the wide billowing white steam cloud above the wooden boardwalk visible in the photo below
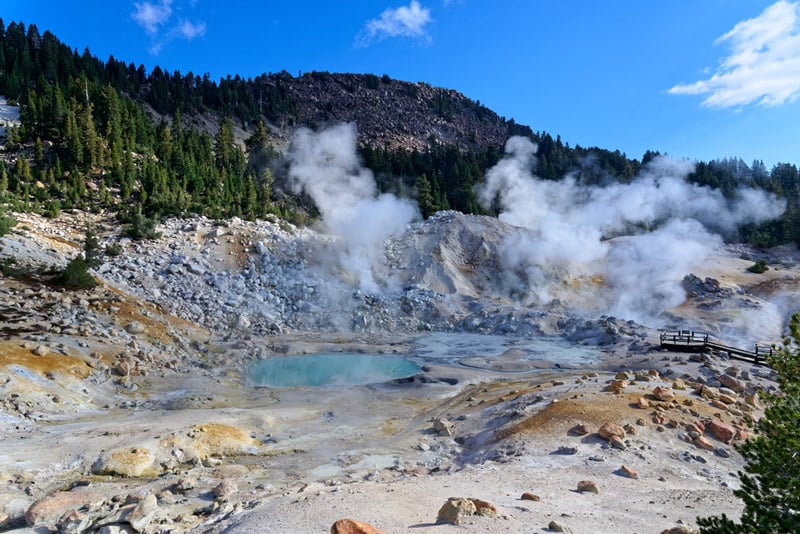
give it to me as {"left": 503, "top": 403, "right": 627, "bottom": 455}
{"left": 477, "top": 137, "right": 785, "bottom": 324}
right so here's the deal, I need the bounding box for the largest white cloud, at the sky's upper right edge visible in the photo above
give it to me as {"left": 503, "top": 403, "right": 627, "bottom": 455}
{"left": 669, "top": 0, "right": 800, "bottom": 108}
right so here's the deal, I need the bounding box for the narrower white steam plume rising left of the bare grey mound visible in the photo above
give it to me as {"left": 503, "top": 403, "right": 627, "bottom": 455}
{"left": 288, "top": 124, "right": 419, "bottom": 293}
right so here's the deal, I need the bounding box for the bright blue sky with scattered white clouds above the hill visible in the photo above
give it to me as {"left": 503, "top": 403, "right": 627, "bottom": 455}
{"left": 0, "top": 0, "right": 800, "bottom": 167}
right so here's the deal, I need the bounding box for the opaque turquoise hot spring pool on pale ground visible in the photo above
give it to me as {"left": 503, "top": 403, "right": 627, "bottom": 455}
{"left": 247, "top": 353, "right": 420, "bottom": 387}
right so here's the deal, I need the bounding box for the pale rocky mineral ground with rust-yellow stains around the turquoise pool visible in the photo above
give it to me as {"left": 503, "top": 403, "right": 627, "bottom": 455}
{"left": 0, "top": 214, "right": 800, "bottom": 534}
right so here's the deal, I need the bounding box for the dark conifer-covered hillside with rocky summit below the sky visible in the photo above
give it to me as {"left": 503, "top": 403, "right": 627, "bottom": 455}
{"left": 0, "top": 20, "right": 800, "bottom": 245}
